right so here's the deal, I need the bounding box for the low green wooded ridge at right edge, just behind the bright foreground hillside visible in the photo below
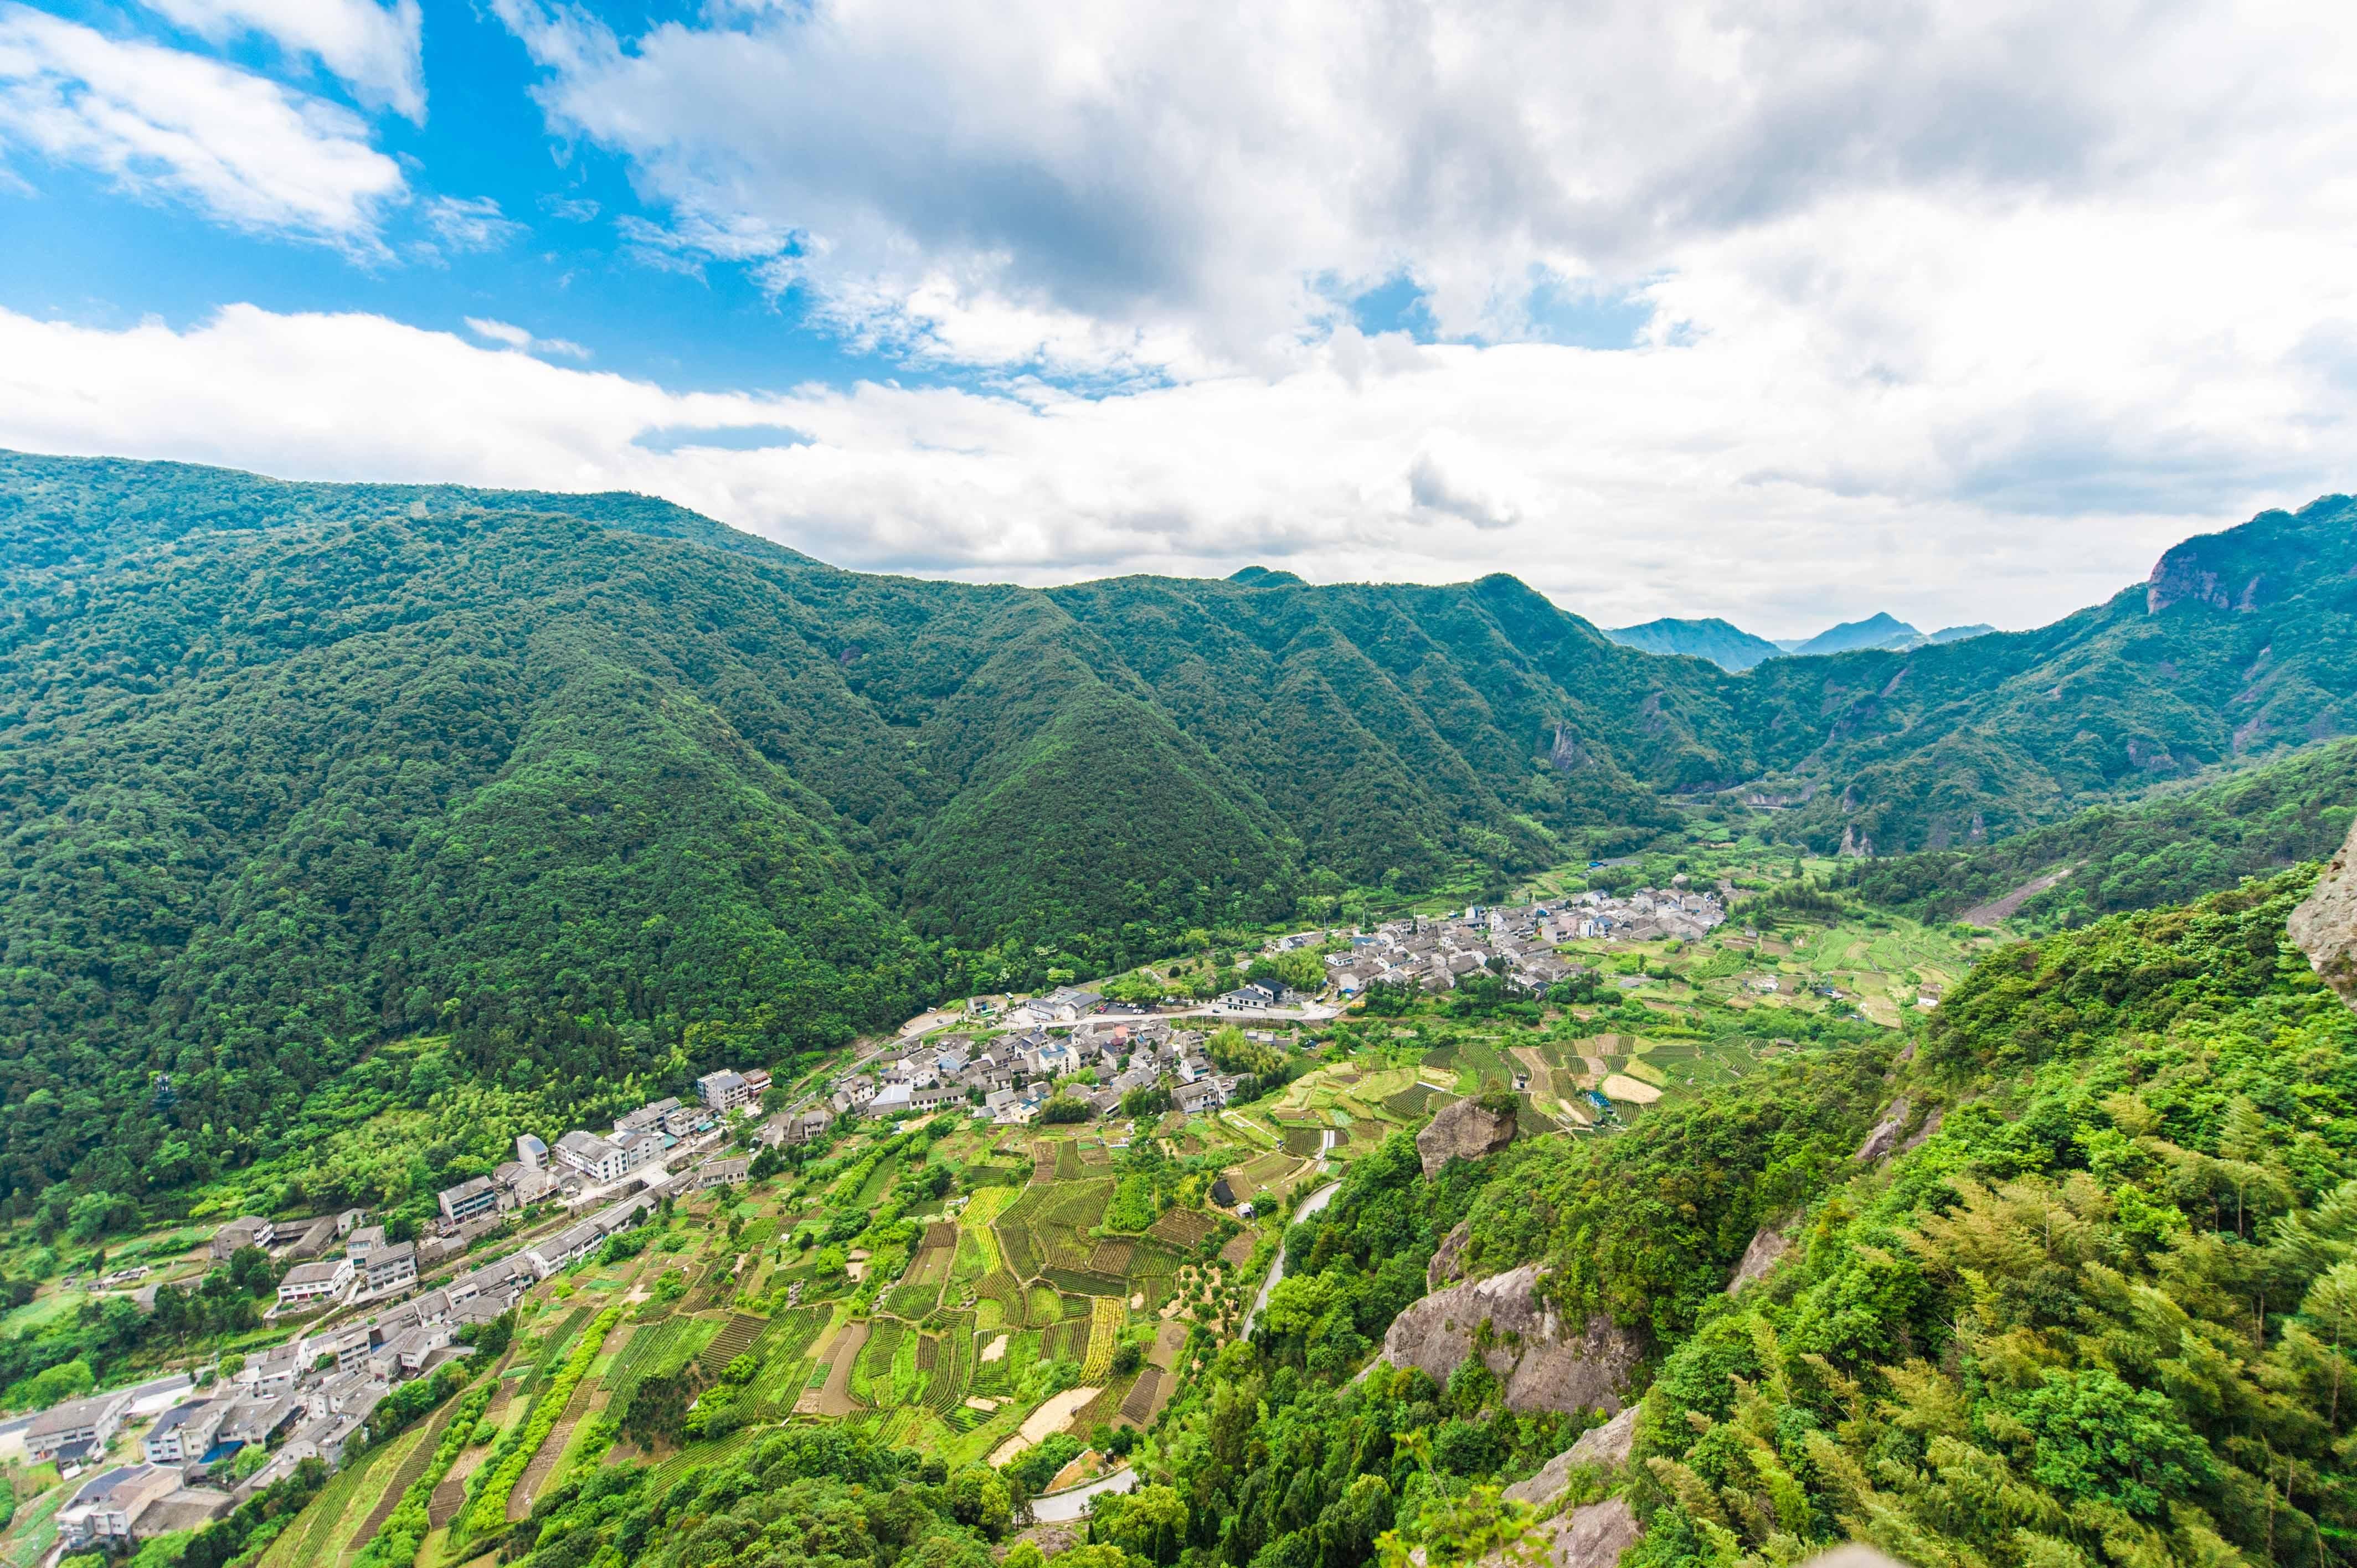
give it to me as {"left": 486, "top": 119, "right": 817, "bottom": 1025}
{"left": 1841, "top": 740, "right": 2357, "bottom": 929}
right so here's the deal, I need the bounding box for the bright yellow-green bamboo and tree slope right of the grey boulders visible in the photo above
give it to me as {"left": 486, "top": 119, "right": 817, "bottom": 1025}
{"left": 1631, "top": 873, "right": 2357, "bottom": 1568}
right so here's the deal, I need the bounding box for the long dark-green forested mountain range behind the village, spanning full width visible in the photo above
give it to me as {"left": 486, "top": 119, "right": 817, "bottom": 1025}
{"left": 0, "top": 445, "right": 2357, "bottom": 1191}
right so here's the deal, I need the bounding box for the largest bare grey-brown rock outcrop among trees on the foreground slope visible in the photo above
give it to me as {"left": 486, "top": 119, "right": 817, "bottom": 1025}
{"left": 1383, "top": 1264, "right": 1640, "bottom": 1412}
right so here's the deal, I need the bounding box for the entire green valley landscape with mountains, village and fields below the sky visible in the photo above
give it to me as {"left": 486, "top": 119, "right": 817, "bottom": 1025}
{"left": 0, "top": 457, "right": 2357, "bottom": 1568}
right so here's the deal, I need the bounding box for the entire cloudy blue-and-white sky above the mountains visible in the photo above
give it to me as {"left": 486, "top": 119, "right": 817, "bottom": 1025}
{"left": 0, "top": 0, "right": 2357, "bottom": 637}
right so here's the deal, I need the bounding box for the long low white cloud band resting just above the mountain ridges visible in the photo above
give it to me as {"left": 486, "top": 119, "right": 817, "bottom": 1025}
{"left": 0, "top": 290, "right": 2357, "bottom": 635}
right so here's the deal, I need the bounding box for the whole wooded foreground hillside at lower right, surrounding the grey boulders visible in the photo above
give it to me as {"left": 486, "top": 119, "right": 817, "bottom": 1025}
{"left": 1121, "top": 868, "right": 2357, "bottom": 1568}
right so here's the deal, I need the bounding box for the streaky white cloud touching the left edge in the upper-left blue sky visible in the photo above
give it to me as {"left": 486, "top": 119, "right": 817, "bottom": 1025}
{"left": 0, "top": 5, "right": 405, "bottom": 255}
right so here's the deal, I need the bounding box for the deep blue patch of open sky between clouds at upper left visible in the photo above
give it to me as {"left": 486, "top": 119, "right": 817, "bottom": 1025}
{"left": 0, "top": 5, "right": 910, "bottom": 389}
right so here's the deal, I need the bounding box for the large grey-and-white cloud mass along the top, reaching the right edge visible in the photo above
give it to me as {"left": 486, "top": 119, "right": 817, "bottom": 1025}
{"left": 495, "top": 0, "right": 2357, "bottom": 375}
